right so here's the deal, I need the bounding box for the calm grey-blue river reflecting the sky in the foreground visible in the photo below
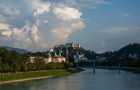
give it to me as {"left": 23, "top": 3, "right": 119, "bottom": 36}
{"left": 0, "top": 68, "right": 140, "bottom": 90}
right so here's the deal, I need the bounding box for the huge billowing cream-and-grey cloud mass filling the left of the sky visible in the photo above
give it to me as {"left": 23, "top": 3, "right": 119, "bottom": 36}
{"left": 0, "top": 0, "right": 86, "bottom": 51}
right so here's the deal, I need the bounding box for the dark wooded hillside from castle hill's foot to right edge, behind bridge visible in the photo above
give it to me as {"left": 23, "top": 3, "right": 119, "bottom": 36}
{"left": 79, "top": 43, "right": 140, "bottom": 67}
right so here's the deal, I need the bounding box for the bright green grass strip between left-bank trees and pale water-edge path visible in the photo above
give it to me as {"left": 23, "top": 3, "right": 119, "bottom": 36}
{"left": 0, "top": 69, "right": 69, "bottom": 82}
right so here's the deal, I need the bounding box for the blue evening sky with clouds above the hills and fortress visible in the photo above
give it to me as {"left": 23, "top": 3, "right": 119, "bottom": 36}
{"left": 0, "top": 0, "right": 140, "bottom": 53}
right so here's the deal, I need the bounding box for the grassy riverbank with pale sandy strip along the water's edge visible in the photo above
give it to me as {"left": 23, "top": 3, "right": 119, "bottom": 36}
{"left": 0, "top": 68, "right": 83, "bottom": 84}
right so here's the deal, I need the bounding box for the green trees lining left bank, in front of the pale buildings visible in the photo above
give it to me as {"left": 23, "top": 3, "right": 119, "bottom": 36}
{"left": 0, "top": 48, "right": 75, "bottom": 73}
